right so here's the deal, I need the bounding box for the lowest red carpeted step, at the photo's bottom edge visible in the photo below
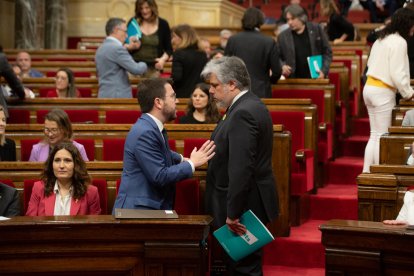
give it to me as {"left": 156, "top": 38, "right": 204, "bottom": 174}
{"left": 263, "top": 265, "right": 325, "bottom": 276}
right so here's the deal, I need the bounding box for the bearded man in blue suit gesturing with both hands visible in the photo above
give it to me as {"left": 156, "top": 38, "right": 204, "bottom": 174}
{"left": 114, "top": 79, "right": 215, "bottom": 210}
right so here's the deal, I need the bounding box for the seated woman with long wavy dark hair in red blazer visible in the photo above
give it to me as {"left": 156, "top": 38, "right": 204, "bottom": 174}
{"left": 26, "top": 141, "right": 101, "bottom": 216}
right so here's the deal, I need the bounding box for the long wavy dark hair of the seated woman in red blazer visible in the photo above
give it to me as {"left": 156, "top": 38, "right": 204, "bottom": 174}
{"left": 41, "top": 140, "right": 91, "bottom": 199}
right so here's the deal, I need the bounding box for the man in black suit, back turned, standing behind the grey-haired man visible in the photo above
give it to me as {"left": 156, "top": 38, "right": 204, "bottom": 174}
{"left": 224, "top": 8, "right": 282, "bottom": 98}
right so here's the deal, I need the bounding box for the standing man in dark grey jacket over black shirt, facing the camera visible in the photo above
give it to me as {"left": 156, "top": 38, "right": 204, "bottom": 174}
{"left": 278, "top": 4, "right": 332, "bottom": 79}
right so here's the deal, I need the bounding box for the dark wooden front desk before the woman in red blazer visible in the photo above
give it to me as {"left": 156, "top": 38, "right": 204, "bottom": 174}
{"left": 0, "top": 215, "right": 212, "bottom": 275}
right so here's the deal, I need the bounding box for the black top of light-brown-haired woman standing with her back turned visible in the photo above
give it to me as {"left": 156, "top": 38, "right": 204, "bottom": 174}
{"left": 171, "top": 48, "right": 207, "bottom": 98}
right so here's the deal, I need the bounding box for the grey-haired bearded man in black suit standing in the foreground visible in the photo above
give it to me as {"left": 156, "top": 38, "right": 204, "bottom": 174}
{"left": 201, "top": 56, "right": 279, "bottom": 275}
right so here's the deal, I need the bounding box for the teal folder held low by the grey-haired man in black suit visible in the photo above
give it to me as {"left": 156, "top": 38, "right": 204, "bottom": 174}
{"left": 213, "top": 210, "right": 274, "bottom": 261}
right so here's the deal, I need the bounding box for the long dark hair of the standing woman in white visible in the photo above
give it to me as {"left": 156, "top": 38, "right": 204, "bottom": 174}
{"left": 378, "top": 8, "right": 414, "bottom": 40}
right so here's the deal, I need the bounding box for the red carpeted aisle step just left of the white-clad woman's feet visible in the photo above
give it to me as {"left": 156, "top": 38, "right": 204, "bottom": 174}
{"left": 325, "top": 156, "right": 364, "bottom": 185}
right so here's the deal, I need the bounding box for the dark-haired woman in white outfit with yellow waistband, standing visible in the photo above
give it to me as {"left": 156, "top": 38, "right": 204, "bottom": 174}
{"left": 363, "top": 9, "right": 414, "bottom": 172}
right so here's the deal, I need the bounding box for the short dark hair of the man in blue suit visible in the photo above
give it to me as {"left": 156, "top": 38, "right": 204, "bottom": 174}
{"left": 137, "top": 78, "right": 169, "bottom": 113}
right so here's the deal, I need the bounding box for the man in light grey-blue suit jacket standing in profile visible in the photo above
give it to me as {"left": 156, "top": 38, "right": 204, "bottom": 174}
{"left": 95, "top": 18, "right": 147, "bottom": 98}
